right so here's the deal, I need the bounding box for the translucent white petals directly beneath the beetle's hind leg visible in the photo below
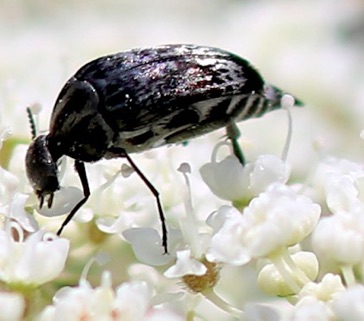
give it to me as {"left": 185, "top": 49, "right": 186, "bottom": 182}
{"left": 200, "top": 145, "right": 289, "bottom": 204}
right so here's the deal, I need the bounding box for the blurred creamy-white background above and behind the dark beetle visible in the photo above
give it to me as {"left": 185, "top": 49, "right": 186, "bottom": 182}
{"left": 0, "top": 0, "right": 364, "bottom": 169}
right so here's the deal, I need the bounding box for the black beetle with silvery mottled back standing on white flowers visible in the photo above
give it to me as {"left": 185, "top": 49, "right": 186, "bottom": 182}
{"left": 25, "top": 44, "right": 300, "bottom": 253}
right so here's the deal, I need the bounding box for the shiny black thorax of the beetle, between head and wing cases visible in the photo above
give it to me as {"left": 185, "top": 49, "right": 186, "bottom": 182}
{"left": 48, "top": 78, "right": 114, "bottom": 162}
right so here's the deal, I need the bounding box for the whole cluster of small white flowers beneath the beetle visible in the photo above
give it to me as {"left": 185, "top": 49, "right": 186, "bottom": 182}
{"left": 0, "top": 89, "right": 364, "bottom": 321}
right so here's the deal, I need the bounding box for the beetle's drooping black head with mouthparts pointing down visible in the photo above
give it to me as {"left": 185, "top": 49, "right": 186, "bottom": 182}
{"left": 25, "top": 135, "right": 59, "bottom": 208}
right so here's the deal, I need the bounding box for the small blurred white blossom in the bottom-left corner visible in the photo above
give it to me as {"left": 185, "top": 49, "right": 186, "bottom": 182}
{"left": 0, "top": 292, "right": 25, "bottom": 321}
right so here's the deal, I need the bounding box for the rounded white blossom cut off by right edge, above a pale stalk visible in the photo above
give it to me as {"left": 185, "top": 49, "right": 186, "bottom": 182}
{"left": 312, "top": 213, "right": 364, "bottom": 265}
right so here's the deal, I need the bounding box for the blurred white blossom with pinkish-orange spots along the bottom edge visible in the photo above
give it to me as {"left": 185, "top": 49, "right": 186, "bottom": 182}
{"left": 40, "top": 272, "right": 181, "bottom": 321}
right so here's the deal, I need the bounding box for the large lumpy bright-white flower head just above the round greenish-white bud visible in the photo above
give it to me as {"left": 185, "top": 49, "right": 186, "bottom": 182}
{"left": 243, "top": 184, "right": 321, "bottom": 257}
